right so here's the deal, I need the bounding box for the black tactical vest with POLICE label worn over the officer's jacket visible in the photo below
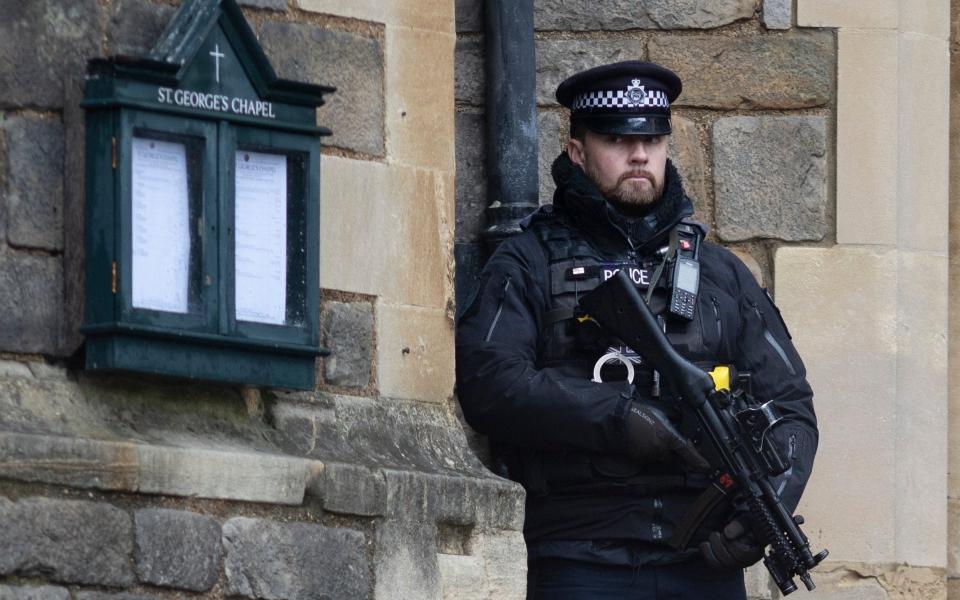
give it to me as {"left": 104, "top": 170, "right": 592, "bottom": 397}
{"left": 511, "top": 212, "right": 720, "bottom": 496}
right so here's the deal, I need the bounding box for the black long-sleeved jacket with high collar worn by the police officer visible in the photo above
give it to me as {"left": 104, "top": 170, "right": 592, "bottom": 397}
{"left": 457, "top": 154, "right": 817, "bottom": 564}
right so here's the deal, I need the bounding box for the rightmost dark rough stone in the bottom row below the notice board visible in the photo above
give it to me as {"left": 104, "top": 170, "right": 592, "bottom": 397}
{"left": 223, "top": 517, "right": 372, "bottom": 600}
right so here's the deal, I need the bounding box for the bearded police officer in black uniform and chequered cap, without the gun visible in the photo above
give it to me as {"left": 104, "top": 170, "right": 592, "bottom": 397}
{"left": 457, "top": 61, "right": 817, "bottom": 599}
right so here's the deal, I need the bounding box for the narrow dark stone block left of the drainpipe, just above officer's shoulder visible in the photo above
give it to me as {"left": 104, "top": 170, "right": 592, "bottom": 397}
{"left": 455, "top": 112, "right": 488, "bottom": 242}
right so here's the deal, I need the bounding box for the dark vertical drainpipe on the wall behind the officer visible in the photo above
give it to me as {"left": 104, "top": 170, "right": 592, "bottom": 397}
{"left": 483, "top": 0, "right": 539, "bottom": 252}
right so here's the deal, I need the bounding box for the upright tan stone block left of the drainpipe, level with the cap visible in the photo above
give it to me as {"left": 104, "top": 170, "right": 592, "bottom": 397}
{"left": 385, "top": 27, "right": 456, "bottom": 171}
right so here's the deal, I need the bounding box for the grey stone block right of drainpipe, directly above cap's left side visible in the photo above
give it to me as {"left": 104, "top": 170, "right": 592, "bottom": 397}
{"left": 536, "top": 38, "right": 640, "bottom": 106}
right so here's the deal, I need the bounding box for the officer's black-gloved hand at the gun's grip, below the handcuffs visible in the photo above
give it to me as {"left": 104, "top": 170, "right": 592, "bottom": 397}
{"left": 627, "top": 402, "right": 710, "bottom": 471}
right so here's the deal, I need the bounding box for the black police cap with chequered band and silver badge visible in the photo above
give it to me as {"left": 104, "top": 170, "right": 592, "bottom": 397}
{"left": 556, "top": 60, "right": 683, "bottom": 135}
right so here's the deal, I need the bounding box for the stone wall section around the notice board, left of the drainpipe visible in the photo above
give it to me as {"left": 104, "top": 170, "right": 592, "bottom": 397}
{"left": 0, "top": 0, "right": 526, "bottom": 600}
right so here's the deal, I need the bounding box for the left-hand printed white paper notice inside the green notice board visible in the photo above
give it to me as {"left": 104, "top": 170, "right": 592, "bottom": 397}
{"left": 131, "top": 138, "right": 190, "bottom": 313}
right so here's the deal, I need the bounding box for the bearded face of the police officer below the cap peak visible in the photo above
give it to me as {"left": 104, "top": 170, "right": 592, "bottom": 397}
{"left": 567, "top": 131, "right": 667, "bottom": 214}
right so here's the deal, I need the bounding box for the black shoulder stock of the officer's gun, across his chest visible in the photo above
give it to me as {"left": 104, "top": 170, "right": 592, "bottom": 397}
{"left": 580, "top": 271, "right": 713, "bottom": 407}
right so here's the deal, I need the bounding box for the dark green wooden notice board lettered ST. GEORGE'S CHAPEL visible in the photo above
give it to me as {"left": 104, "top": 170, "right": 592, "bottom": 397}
{"left": 82, "top": 0, "right": 334, "bottom": 389}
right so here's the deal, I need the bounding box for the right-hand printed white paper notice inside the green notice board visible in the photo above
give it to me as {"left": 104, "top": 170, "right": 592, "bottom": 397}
{"left": 234, "top": 151, "right": 287, "bottom": 325}
